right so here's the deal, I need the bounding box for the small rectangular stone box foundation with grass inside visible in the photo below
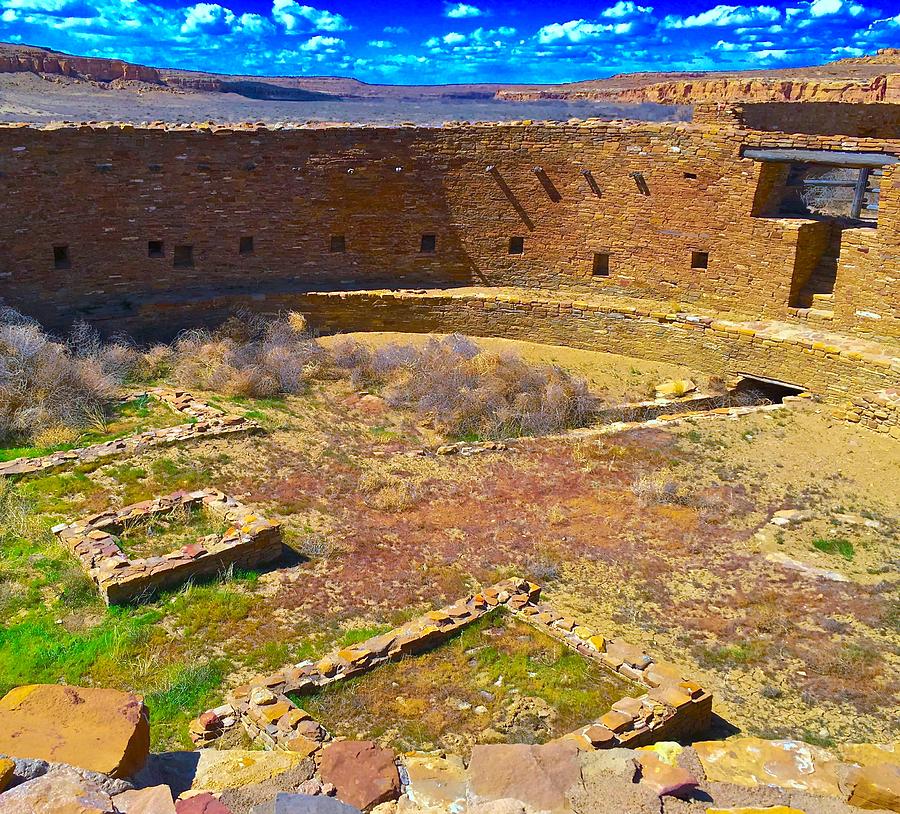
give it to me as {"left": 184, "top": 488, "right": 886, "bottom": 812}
{"left": 53, "top": 489, "right": 282, "bottom": 605}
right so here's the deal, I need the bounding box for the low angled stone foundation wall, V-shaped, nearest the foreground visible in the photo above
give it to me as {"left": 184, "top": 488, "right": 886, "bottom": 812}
{"left": 191, "top": 579, "right": 712, "bottom": 755}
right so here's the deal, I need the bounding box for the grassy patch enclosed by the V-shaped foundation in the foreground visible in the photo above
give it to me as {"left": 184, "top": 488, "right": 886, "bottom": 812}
{"left": 295, "top": 611, "right": 641, "bottom": 753}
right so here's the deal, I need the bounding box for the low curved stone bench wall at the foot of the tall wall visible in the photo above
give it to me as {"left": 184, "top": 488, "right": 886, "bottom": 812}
{"left": 288, "top": 291, "right": 900, "bottom": 404}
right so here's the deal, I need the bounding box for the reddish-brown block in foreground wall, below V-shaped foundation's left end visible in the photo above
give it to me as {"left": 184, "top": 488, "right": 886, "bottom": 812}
{"left": 319, "top": 741, "right": 400, "bottom": 811}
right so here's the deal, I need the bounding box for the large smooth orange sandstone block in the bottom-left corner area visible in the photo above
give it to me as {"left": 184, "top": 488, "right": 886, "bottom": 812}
{"left": 0, "top": 684, "right": 150, "bottom": 777}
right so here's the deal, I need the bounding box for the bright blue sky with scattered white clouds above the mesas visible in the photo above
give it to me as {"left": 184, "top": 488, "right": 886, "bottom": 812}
{"left": 0, "top": 0, "right": 900, "bottom": 84}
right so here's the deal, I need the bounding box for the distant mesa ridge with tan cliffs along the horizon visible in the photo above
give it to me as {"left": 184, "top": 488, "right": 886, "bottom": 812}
{"left": 0, "top": 43, "right": 900, "bottom": 105}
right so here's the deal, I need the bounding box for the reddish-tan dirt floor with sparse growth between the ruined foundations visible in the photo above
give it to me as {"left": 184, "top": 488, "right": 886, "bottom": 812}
{"left": 3, "top": 336, "right": 900, "bottom": 744}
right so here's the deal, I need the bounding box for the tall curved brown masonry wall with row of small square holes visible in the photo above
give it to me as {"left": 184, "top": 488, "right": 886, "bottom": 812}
{"left": 0, "top": 111, "right": 900, "bottom": 336}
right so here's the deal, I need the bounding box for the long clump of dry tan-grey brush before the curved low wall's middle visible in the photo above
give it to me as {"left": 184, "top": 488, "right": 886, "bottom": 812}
{"left": 172, "top": 320, "right": 597, "bottom": 438}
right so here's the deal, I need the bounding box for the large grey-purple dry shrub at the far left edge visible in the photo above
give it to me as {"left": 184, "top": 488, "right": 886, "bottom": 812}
{"left": 0, "top": 308, "right": 138, "bottom": 444}
